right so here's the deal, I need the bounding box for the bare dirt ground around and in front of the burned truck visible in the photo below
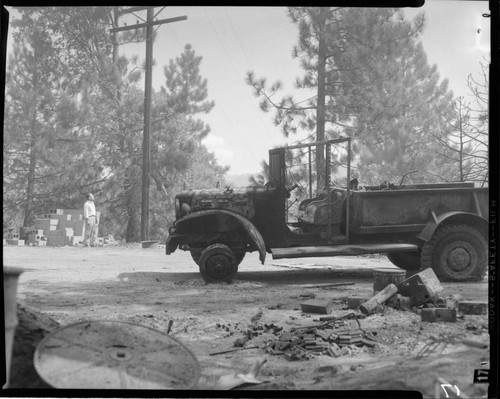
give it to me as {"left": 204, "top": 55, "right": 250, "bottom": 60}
{"left": 3, "top": 245, "right": 489, "bottom": 398}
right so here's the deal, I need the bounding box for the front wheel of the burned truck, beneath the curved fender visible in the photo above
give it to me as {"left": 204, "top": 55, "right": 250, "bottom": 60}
{"left": 198, "top": 244, "right": 238, "bottom": 283}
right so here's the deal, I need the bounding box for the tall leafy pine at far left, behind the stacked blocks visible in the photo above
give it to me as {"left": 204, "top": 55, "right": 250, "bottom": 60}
{"left": 4, "top": 14, "right": 98, "bottom": 230}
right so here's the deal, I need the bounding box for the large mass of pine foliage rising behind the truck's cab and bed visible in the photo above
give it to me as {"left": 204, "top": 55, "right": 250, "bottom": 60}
{"left": 247, "top": 7, "right": 452, "bottom": 184}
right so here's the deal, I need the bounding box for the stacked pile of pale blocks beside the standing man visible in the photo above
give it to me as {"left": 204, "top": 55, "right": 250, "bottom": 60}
{"left": 28, "top": 209, "right": 100, "bottom": 246}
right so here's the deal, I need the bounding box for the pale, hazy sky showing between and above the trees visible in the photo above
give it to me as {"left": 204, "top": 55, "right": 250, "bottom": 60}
{"left": 5, "top": 0, "right": 490, "bottom": 175}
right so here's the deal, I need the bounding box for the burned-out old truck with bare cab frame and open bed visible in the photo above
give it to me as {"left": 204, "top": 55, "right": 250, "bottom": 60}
{"left": 166, "top": 138, "right": 488, "bottom": 282}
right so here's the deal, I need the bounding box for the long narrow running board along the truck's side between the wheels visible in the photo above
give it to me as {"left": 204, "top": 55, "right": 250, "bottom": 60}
{"left": 271, "top": 244, "right": 418, "bottom": 259}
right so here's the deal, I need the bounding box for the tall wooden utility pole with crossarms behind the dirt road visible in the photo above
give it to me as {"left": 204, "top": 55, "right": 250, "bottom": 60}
{"left": 111, "top": 7, "right": 187, "bottom": 241}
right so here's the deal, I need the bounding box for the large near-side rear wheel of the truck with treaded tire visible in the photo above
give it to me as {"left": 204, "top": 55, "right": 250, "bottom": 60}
{"left": 421, "top": 224, "right": 488, "bottom": 281}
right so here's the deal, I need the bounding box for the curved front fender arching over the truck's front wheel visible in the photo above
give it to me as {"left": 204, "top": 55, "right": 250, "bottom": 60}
{"left": 175, "top": 209, "right": 266, "bottom": 264}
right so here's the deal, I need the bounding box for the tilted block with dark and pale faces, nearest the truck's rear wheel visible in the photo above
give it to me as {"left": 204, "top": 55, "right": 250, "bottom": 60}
{"left": 397, "top": 268, "right": 443, "bottom": 306}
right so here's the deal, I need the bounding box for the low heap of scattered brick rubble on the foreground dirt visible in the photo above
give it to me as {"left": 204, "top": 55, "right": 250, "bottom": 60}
{"left": 266, "top": 320, "right": 377, "bottom": 361}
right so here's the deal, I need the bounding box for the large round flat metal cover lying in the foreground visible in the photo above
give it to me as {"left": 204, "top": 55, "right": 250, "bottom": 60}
{"left": 34, "top": 321, "right": 200, "bottom": 389}
